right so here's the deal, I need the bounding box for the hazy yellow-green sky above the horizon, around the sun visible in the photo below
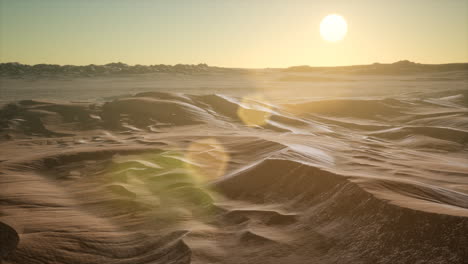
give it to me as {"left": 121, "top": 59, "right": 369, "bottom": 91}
{"left": 0, "top": 0, "right": 468, "bottom": 68}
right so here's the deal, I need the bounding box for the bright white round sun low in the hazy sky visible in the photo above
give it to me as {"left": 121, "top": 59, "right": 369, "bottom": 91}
{"left": 320, "top": 14, "right": 348, "bottom": 42}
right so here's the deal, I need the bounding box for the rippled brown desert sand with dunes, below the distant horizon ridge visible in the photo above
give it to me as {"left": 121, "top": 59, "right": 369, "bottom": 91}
{"left": 0, "top": 70, "right": 468, "bottom": 264}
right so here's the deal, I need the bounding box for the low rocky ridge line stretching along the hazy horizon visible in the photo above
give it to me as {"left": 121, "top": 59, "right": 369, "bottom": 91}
{"left": 0, "top": 60, "right": 468, "bottom": 79}
